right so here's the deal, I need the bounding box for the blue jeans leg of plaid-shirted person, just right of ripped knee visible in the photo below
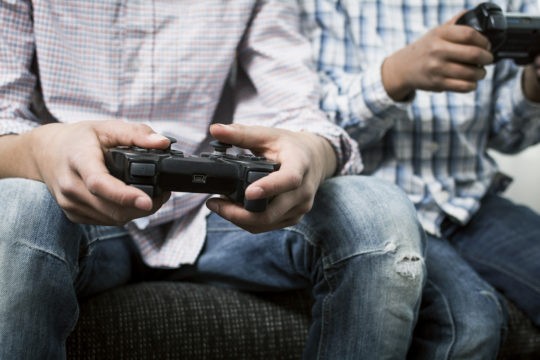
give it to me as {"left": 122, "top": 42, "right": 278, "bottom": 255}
{"left": 414, "top": 236, "right": 507, "bottom": 360}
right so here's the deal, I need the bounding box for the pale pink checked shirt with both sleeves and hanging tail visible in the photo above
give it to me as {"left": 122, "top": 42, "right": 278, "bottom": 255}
{"left": 0, "top": 0, "right": 361, "bottom": 267}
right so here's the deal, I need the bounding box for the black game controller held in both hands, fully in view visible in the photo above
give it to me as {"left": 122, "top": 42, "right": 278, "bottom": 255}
{"left": 105, "top": 138, "right": 279, "bottom": 212}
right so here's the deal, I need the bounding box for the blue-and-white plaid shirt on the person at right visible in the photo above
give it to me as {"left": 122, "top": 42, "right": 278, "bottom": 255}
{"left": 300, "top": 0, "right": 540, "bottom": 234}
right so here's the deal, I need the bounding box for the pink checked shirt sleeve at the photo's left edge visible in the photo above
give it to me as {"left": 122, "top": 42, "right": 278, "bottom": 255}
{"left": 0, "top": 0, "right": 38, "bottom": 135}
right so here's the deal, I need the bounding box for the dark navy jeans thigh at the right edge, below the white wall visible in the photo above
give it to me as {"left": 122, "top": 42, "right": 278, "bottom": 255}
{"left": 452, "top": 195, "right": 540, "bottom": 325}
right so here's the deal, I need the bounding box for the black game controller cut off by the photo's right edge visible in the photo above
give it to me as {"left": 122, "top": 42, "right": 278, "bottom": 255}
{"left": 456, "top": 3, "right": 540, "bottom": 65}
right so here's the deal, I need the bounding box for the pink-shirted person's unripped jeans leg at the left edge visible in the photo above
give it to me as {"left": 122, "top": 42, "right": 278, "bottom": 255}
{"left": 0, "top": 179, "right": 134, "bottom": 360}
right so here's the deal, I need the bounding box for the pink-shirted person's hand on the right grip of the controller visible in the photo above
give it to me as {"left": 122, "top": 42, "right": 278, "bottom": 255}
{"left": 207, "top": 124, "right": 336, "bottom": 233}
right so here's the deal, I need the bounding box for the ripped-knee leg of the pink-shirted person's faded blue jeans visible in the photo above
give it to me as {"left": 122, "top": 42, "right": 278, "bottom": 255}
{"left": 165, "top": 176, "right": 425, "bottom": 360}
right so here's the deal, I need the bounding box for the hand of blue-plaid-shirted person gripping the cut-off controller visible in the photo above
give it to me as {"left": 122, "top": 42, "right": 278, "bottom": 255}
{"left": 381, "top": 13, "right": 493, "bottom": 101}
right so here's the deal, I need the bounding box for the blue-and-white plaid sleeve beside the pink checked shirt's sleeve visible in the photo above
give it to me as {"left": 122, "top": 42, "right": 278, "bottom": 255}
{"left": 302, "top": 1, "right": 414, "bottom": 149}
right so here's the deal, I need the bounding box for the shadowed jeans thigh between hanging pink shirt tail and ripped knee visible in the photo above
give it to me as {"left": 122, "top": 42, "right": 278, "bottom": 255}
{"left": 165, "top": 213, "right": 314, "bottom": 291}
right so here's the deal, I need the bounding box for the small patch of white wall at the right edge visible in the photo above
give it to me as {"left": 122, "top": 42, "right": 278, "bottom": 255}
{"left": 491, "top": 145, "right": 540, "bottom": 213}
